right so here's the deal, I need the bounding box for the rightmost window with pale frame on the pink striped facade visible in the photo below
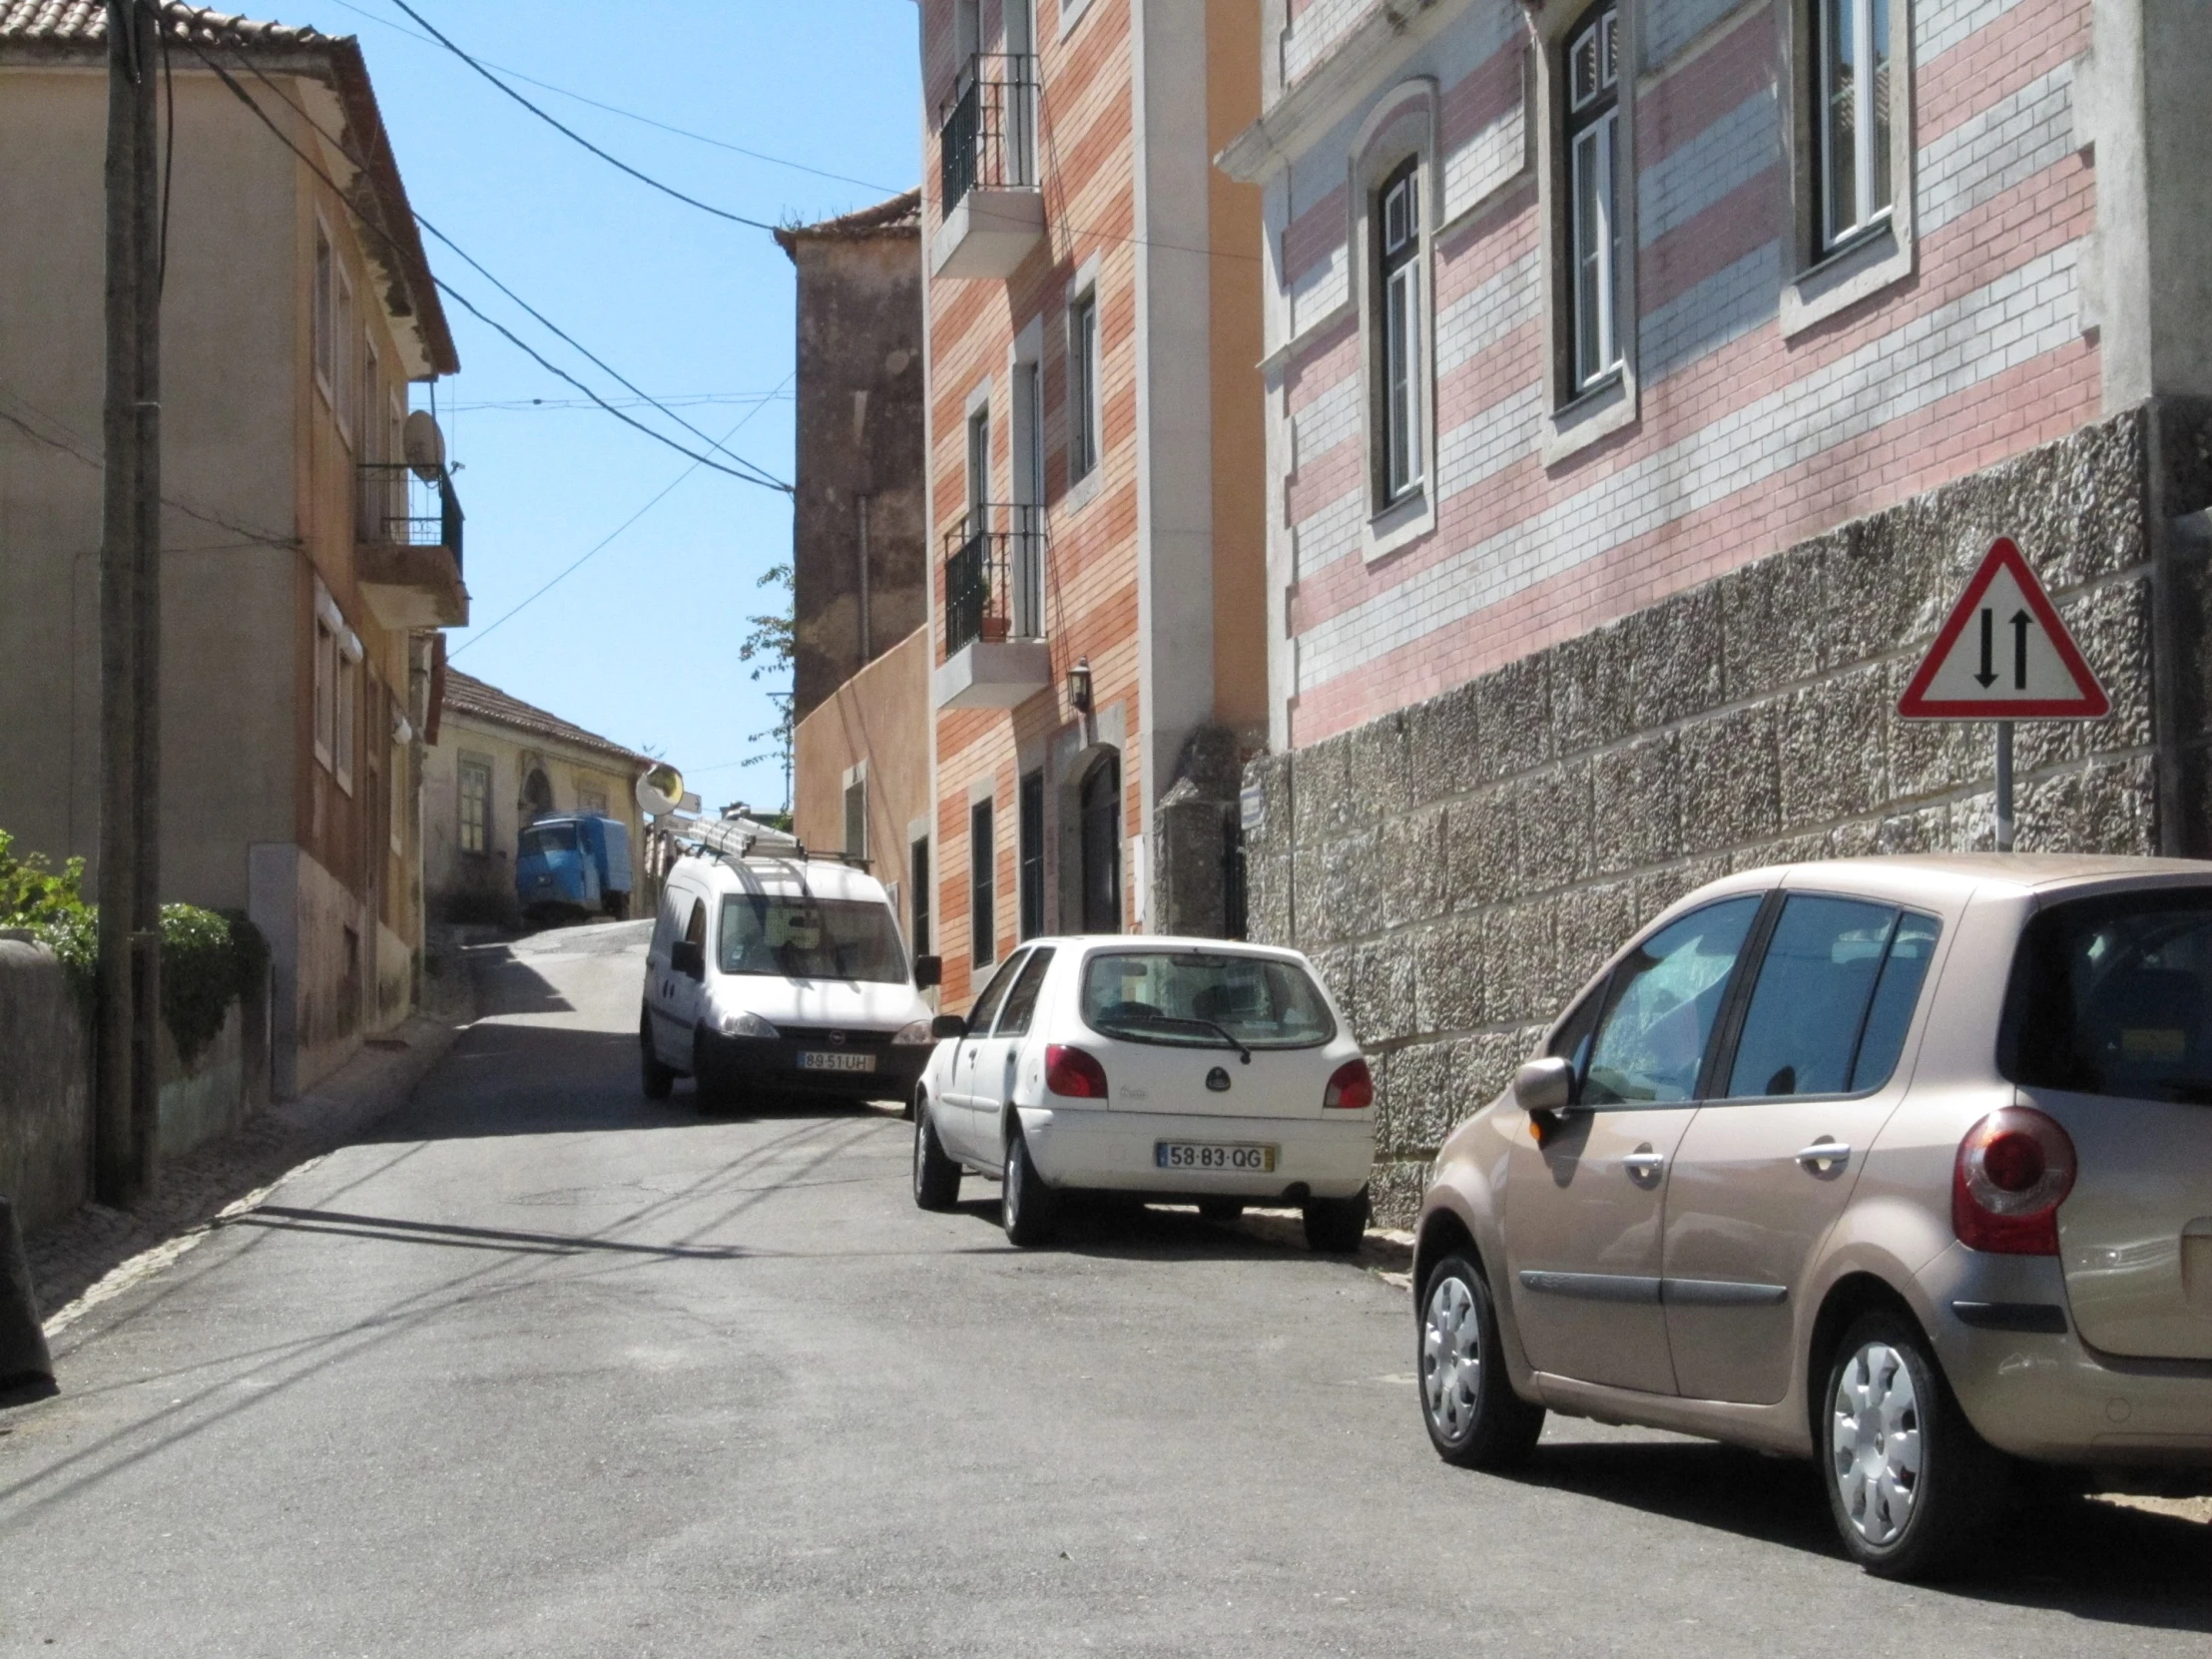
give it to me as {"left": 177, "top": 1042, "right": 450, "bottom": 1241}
{"left": 1779, "top": 0, "right": 1918, "bottom": 338}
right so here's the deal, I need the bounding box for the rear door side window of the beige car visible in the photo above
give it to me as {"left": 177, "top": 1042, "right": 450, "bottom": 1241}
{"left": 1723, "top": 893, "right": 1898, "bottom": 1099}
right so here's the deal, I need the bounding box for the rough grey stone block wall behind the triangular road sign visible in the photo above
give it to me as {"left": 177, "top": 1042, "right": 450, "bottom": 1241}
{"left": 1246, "top": 407, "right": 2212, "bottom": 1219}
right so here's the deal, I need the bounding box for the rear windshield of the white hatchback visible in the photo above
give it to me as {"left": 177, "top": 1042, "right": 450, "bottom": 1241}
{"left": 1084, "top": 951, "right": 1336, "bottom": 1048}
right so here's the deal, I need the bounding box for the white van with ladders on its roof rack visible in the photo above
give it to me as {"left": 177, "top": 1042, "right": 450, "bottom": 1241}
{"left": 637, "top": 826, "right": 938, "bottom": 1108}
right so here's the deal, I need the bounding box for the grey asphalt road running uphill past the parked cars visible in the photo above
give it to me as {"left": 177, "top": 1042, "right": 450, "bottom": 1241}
{"left": 0, "top": 924, "right": 2212, "bottom": 1659}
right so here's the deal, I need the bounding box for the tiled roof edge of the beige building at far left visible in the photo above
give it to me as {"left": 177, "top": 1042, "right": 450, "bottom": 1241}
{"left": 0, "top": 0, "right": 460, "bottom": 374}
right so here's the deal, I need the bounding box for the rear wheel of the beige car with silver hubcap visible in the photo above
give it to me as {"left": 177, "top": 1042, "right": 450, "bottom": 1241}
{"left": 1821, "top": 1310, "right": 2010, "bottom": 1579}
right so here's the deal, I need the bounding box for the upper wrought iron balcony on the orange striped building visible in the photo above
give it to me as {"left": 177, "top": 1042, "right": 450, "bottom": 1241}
{"left": 931, "top": 53, "right": 1044, "bottom": 276}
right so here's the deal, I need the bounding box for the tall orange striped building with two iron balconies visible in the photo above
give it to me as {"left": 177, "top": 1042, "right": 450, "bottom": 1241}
{"left": 910, "top": 0, "right": 1268, "bottom": 1008}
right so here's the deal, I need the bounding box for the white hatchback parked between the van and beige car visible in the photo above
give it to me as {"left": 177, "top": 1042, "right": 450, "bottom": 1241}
{"left": 913, "top": 933, "right": 1374, "bottom": 1250}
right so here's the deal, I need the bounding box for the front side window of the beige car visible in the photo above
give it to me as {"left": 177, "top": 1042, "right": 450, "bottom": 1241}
{"left": 1581, "top": 893, "right": 1761, "bottom": 1106}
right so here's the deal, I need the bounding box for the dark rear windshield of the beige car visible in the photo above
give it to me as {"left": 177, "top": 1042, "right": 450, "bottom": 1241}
{"left": 1997, "top": 887, "right": 2212, "bottom": 1104}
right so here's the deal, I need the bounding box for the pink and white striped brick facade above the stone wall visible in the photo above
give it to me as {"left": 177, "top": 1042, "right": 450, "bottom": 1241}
{"left": 1270, "top": 0, "right": 2101, "bottom": 748}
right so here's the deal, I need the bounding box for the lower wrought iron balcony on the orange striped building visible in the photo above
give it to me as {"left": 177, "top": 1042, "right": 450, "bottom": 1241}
{"left": 935, "top": 502, "right": 1053, "bottom": 708}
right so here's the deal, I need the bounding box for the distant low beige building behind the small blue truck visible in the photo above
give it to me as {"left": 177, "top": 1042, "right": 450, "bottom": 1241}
{"left": 422, "top": 668, "right": 653, "bottom": 922}
